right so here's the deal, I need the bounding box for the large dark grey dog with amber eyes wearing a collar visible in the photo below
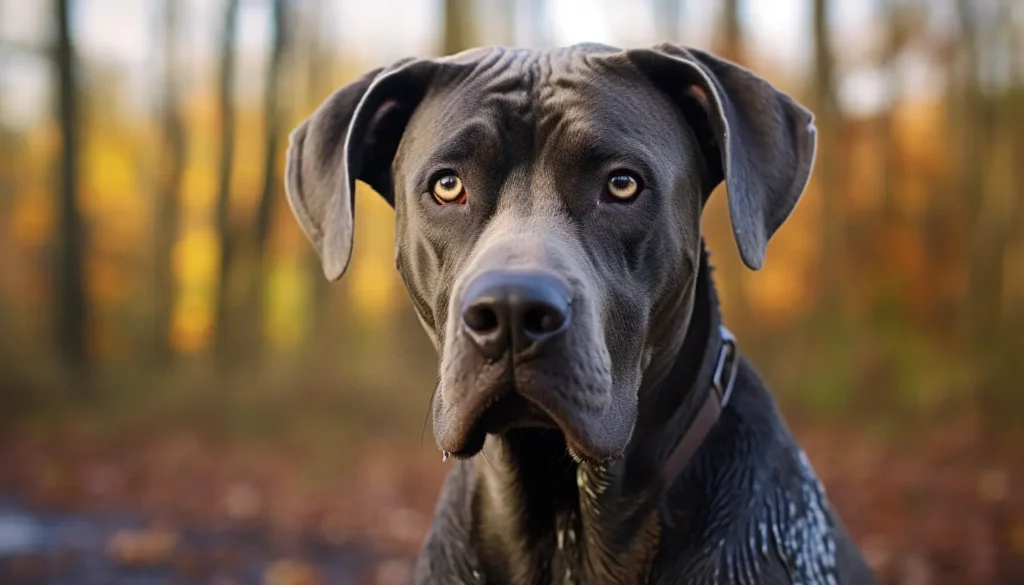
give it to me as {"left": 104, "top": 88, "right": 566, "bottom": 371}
{"left": 286, "top": 44, "right": 876, "bottom": 585}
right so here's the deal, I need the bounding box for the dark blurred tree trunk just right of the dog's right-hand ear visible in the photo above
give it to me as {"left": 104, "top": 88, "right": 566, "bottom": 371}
{"left": 812, "top": 0, "right": 847, "bottom": 316}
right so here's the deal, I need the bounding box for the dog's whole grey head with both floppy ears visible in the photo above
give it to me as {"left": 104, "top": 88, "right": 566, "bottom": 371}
{"left": 287, "top": 45, "right": 815, "bottom": 461}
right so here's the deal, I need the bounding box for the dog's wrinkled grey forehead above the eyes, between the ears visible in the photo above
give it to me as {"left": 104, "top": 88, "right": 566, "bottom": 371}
{"left": 401, "top": 44, "right": 678, "bottom": 165}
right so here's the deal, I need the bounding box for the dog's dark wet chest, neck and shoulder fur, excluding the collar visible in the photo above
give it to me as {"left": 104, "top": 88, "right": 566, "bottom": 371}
{"left": 416, "top": 254, "right": 876, "bottom": 585}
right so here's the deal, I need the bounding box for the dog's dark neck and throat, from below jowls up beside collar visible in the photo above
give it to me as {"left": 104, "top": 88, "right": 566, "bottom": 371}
{"left": 466, "top": 247, "right": 721, "bottom": 583}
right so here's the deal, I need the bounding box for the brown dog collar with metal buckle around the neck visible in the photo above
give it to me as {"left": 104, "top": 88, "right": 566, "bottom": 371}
{"left": 664, "top": 325, "right": 739, "bottom": 484}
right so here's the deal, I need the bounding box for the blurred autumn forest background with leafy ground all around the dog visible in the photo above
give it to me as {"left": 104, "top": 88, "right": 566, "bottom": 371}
{"left": 0, "top": 0, "right": 1024, "bottom": 585}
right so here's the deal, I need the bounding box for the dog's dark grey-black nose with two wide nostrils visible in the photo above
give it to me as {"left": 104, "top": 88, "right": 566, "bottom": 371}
{"left": 462, "top": 270, "right": 571, "bottom": 360}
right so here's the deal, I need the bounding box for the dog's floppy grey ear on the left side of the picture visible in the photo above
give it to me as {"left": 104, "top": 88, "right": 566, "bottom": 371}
{"left": 285, "top": 58, "right": 438, "bottom": 281}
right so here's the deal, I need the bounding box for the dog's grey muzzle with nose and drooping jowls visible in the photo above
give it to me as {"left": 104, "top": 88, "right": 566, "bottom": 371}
{"left": 432, "top": 238, "right": 633, "bottom": 460}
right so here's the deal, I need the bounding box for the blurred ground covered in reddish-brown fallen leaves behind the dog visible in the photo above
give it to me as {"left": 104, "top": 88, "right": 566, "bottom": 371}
{"left": 0, "top": 421, "right": 1024, "bottom": 585}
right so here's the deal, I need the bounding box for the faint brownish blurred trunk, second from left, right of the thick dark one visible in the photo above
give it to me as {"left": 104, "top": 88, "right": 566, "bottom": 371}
{"left": 154, "top": 0, "right": 185, "bottom": 364}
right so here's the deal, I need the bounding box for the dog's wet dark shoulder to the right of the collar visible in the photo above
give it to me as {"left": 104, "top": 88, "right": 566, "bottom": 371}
{"left": 657, "top": 362, "right": 873, "bottom": 584}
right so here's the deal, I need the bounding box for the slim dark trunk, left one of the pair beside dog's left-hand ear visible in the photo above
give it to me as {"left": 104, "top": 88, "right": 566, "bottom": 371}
{"left": 214, "top": 0, "right": 239, "bottom": 360}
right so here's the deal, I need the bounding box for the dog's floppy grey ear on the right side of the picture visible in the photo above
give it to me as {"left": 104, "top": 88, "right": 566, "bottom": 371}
{"left": 629, "top": 44, "right": 817, "bottom": 270}
